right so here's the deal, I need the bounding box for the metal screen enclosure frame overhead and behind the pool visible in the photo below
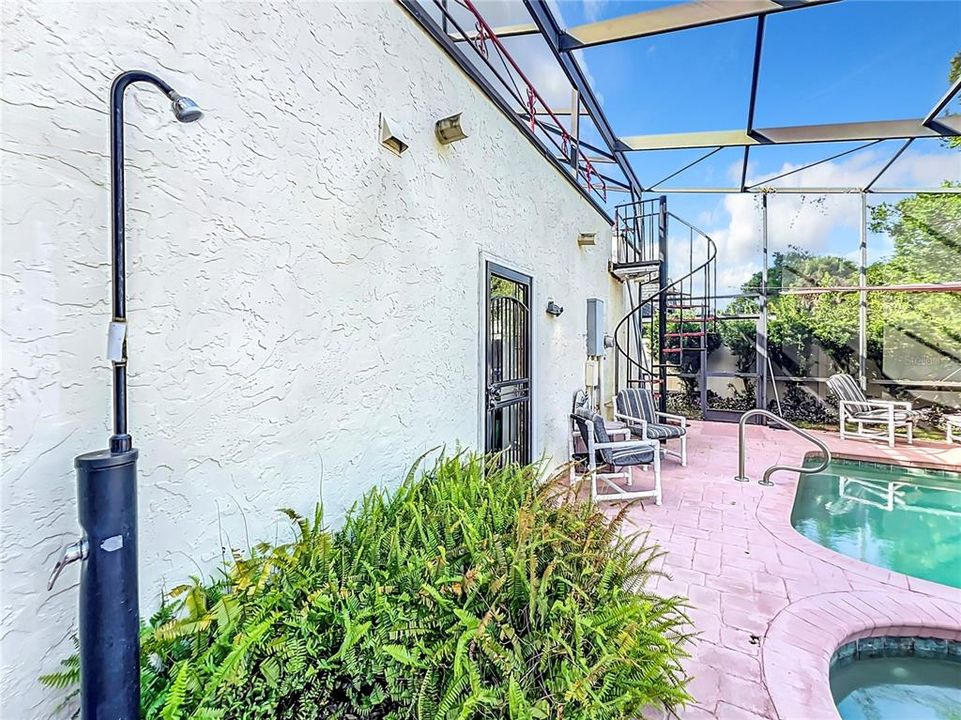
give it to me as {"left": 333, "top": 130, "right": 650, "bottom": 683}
{"left": 398, "top": 0, "right": 961, "bottom": 416}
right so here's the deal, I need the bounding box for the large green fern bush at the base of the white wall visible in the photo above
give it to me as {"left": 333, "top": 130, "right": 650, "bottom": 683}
{"left": 45, "top": 456, "right": 690, "bottom": 720}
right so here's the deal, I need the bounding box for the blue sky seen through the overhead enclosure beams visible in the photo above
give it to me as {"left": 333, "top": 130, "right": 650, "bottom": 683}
{"left": 558, "top": 0, "right": 961, "bottom": 186}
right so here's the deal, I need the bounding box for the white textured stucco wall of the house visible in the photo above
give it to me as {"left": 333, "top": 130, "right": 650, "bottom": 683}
{"left": 0, "top": 2, "right": 620, "bottom": 719}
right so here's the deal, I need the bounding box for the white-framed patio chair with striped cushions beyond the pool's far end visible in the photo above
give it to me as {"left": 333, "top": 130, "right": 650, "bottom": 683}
{"left": 828, "top": 373, "right": 917, "bottom": 447}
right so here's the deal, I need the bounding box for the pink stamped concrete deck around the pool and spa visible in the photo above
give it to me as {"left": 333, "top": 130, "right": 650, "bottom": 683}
{"left": 611, "top": 422, "right": 961, "bottom": 720}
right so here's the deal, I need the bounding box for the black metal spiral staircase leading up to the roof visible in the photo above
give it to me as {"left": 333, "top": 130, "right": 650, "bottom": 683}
{"left": 611, "top": 196, "right": 717, "bottom": 417}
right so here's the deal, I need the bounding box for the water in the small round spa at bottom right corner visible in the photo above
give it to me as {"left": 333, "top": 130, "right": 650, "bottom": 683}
{"left": 831, "top": 657, "right": 961, "bottom": 720}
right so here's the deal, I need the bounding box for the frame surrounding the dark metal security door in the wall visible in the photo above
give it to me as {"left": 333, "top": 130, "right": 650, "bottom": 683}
{"left": 477, "top": 251, "right": 540, "bottom": 462}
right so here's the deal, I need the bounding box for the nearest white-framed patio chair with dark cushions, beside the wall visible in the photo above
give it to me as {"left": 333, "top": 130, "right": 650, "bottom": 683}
{"left": 571, "top": 412, "right": 661, "bottom": 505}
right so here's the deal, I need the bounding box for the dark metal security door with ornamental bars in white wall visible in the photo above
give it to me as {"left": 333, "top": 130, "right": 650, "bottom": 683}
{"left": 484, "top": 263, "right": 531, "bottom": 463}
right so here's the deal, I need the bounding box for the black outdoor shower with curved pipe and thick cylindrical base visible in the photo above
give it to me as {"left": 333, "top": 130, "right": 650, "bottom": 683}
{"left": 50, "top": 70, "right": 201, "bottom": 720}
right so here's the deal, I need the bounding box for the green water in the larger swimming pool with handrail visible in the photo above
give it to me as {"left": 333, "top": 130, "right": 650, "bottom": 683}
{"left": 791, "top": 459, "right": 961, "bottom": 588}
